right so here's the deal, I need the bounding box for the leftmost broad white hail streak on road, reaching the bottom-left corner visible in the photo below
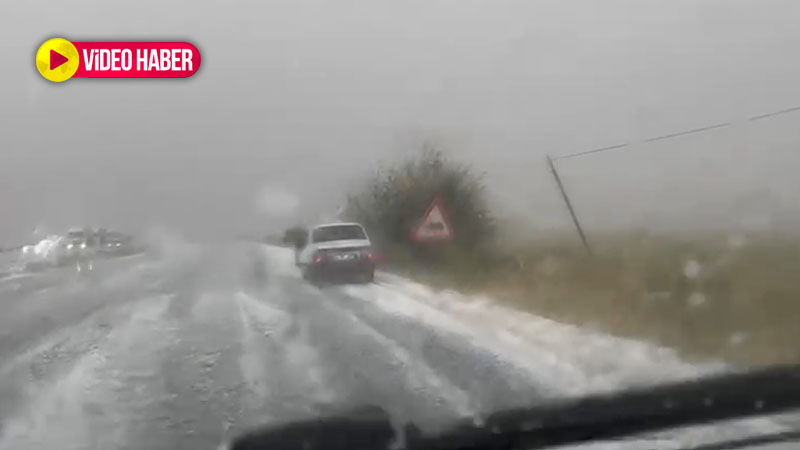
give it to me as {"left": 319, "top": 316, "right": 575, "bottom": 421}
{"left": 0, "top": 296, "right": 175, "bottom": 450}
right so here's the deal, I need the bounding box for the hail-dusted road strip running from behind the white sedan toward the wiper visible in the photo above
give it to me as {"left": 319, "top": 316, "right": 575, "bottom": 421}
{"left": 266, "top": 278, "right": 476, "bottom": 432}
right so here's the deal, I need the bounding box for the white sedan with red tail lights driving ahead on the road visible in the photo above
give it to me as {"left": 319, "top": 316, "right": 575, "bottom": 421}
{"left": 295, "top": 223, "right": 377, "bottom": 283}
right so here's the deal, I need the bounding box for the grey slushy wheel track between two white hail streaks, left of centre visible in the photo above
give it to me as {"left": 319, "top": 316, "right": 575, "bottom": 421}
{"left": 136, "top": 292, "right": 247, "bottom": 449}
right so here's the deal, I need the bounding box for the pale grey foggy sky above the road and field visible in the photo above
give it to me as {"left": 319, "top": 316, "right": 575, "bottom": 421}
{"left": 0, "top": 0, "right": 800, "bottom": 245}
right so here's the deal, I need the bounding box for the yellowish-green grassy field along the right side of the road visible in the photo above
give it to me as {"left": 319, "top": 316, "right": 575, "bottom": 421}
{"left": 380, "top": 233, "right": 800, "bottom": 365}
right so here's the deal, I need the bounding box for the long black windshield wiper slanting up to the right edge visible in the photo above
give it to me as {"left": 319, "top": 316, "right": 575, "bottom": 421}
{"left": 412, "top": 366, "right": 800, "bottom": 449}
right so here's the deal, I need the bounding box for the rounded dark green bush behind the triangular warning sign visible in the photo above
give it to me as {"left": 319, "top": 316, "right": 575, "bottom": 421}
{"left": 345, "top": 146, "right": 495, "bottom": 266}
